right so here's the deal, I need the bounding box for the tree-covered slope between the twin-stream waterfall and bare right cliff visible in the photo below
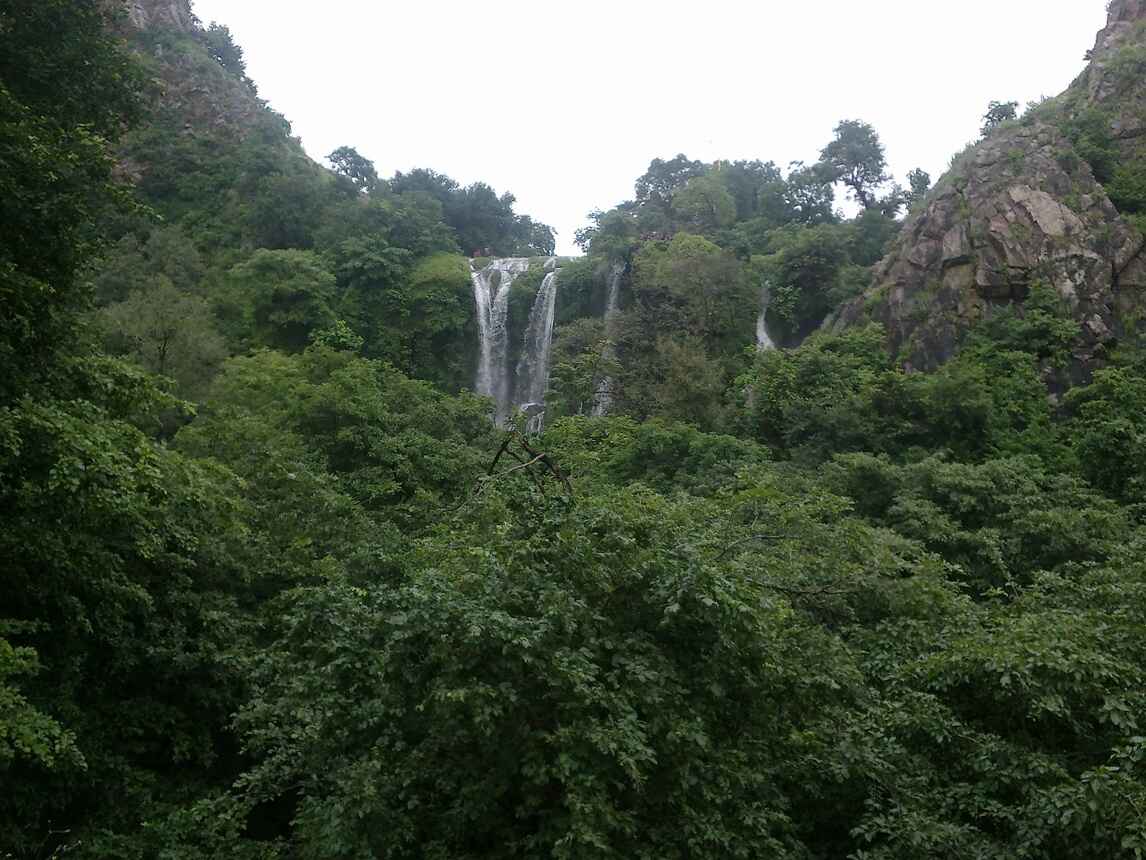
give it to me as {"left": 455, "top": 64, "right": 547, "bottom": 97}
{"left": 555, "top": 120, "right": 931, "bottom": 428}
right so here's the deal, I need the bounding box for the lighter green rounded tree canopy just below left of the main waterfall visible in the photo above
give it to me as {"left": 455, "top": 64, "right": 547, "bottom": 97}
{"left": 179, "top": 345, "right": 495, "bottom": 529}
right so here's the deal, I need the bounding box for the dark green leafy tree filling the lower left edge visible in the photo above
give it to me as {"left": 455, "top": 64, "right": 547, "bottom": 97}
{"left": 0, "top": 382, "right": 252, "bottom": 857}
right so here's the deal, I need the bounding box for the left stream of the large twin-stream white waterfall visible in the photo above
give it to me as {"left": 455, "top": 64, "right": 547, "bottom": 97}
{"left": 471, "top": 257, "right": 529, "bottom": 423}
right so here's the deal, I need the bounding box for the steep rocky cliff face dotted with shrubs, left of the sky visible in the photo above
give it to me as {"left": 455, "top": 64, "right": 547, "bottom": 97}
{"left": 112, "top": 0, "right": 329, "bottom": 248}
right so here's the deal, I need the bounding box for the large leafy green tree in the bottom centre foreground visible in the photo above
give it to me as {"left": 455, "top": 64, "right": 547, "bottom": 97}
{"left": 225, "top": 487, "right": 854, "bottom": 860}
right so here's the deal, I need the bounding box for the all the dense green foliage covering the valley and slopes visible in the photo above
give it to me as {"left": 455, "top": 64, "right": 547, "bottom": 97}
{"left": 0, "top": 0, "right": 1146, "bottom": 860}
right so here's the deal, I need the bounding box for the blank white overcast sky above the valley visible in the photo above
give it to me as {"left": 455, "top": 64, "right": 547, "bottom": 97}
{"left": 187, "top": 0, "right": 1106, "bottom": 253}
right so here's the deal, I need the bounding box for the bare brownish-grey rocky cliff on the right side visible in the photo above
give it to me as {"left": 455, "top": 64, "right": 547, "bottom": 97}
{"left": 832, "top": 0, "right": 1146, "bottom": 373}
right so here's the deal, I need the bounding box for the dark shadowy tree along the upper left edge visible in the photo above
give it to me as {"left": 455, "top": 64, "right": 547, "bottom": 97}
{"left": 0, "top": 0, "right": 143, "bottom": 404}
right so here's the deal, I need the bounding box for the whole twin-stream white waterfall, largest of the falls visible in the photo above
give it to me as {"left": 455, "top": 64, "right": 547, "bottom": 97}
{"left": 471, "top": 257, "right": 560, "bottom": 432}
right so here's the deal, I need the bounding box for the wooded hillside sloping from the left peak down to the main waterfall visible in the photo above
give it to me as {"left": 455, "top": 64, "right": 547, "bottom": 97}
{"left": 93, "top": 0, "right": 554, "bottom": 400}
